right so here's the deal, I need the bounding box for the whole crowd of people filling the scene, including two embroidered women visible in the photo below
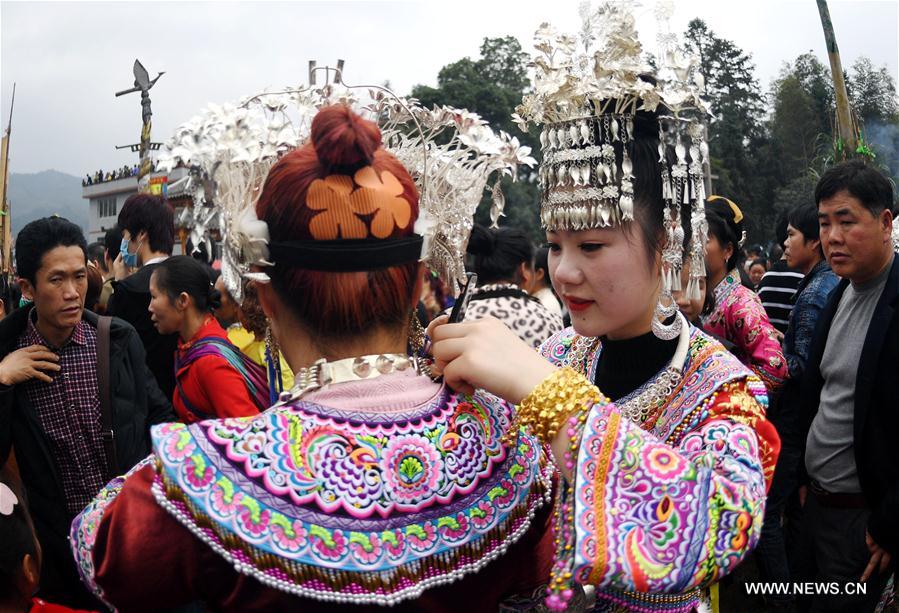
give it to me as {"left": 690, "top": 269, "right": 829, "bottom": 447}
{"left": 0, "top": 5, "right": 899, "bottom": 612}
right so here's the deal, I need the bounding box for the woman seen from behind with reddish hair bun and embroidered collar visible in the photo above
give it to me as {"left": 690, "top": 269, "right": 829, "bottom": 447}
{"left": 71, "top": 105, "right": 553, "bottom": 613}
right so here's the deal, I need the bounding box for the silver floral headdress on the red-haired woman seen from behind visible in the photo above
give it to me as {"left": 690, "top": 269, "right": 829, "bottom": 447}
{"left": 160, "top": 62, "right": 536, "bottom": 301}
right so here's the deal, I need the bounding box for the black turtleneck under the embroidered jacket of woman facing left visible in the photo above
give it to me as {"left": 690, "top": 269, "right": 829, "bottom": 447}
{"left": 595, "top": 332, "right": 678, "bottom": 401}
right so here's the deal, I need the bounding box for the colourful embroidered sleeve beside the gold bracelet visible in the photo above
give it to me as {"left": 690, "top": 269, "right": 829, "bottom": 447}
{"left": 573, "top": 382, "right": 779, "bottom": 593}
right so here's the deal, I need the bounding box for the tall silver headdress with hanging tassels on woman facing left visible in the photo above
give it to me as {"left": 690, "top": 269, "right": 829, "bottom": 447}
{"left": 514, "top": 0, "right": 708, "bottom": 297}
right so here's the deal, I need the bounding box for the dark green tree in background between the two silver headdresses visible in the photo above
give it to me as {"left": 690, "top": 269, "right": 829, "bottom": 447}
{"left": 412, "top": 36, "right": 544, "bottom": 241}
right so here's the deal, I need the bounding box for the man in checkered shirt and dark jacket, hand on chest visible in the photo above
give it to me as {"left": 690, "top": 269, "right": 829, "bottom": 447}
{"left": 0, "top": 217, "right": 174, "bottom": 608}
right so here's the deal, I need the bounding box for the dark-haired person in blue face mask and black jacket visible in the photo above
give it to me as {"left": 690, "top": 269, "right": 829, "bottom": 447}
{"left": 106, "top": 194, "right": 178, "bottom": 399}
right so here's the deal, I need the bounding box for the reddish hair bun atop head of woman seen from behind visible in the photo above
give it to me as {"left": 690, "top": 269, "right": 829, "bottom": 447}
{"left": 311, "top": 105, "right": 381, "bottom": 168}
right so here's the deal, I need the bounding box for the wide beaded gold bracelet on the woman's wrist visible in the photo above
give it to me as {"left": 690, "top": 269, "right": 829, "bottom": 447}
{"left": 509, "top": 367, "right": 608, "bottom": 443}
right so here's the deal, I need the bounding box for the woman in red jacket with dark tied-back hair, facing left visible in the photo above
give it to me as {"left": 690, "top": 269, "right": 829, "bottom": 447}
{"left": 150, "top": 256, "right": 268, "bottom": 424}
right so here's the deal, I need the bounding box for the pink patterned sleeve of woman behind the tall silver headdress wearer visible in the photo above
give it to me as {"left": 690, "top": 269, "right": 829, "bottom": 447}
{"left": 727, "top": 290, "right": 788, "bottom": 391}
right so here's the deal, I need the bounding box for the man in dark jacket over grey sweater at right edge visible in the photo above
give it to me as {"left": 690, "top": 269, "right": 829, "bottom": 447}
{"left": 800, "top": 160, "right": 899, "bottom": 611}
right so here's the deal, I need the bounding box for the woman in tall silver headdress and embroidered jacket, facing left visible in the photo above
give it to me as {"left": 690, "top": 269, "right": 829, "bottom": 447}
{"left": 430, "top": 4, "right": 779, "bottom": 612}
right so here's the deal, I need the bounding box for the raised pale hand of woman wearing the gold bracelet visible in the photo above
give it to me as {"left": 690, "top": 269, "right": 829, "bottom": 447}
{"left": 428, "top": 316, "right": 555, "bottom": 404}
